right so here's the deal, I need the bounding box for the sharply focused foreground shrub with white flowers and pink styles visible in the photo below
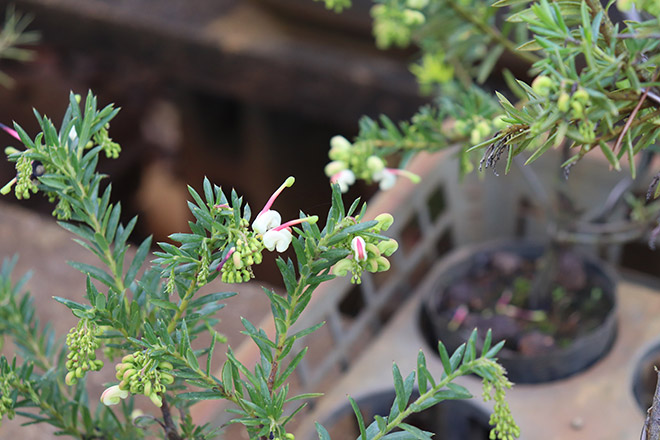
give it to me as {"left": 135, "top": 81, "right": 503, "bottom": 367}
{"left": 0, "top": 93, "right": 518, "bottom": 440}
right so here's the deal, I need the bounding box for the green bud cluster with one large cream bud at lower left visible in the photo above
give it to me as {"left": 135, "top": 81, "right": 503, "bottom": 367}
{"left": 111, "top": 351, "right": 174, "bottom": 407}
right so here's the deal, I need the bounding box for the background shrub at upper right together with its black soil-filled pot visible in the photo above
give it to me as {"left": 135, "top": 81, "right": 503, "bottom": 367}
{"left": 326, "top": 0, "right": 660, "bottom": 388}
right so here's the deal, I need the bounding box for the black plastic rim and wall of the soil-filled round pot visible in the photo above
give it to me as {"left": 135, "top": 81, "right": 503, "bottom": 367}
{"left": 420, "top": 241, "right": 616, "bottom": 383}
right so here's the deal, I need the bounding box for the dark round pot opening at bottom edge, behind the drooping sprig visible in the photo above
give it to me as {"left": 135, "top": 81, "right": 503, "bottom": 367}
{"left": 323, "top": 390, "right": 491, "bottom": 440}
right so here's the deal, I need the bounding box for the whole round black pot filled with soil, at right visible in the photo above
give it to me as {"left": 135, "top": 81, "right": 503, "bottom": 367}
{"left": 422, "top": 242, "right": 616, "bottom": 383}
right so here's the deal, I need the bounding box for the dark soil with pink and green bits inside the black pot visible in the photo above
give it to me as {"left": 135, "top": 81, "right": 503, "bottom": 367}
{"left": 437, "top": 251, "right": 613, "bottom": 355}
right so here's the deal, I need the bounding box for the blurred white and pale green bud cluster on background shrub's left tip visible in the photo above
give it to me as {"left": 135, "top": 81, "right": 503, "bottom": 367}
{"left": 325, "top": 136, "right": 420, "bottom": 192}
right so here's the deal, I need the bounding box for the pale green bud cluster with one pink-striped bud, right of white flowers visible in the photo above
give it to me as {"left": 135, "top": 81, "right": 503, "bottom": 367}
{"left": 332, "top": 214, "right": 399, "bottom": 284}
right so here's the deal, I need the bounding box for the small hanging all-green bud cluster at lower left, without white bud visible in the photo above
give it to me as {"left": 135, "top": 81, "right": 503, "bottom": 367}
{"left": 64, "top": 319, "right": 103, "bottom": 385}
